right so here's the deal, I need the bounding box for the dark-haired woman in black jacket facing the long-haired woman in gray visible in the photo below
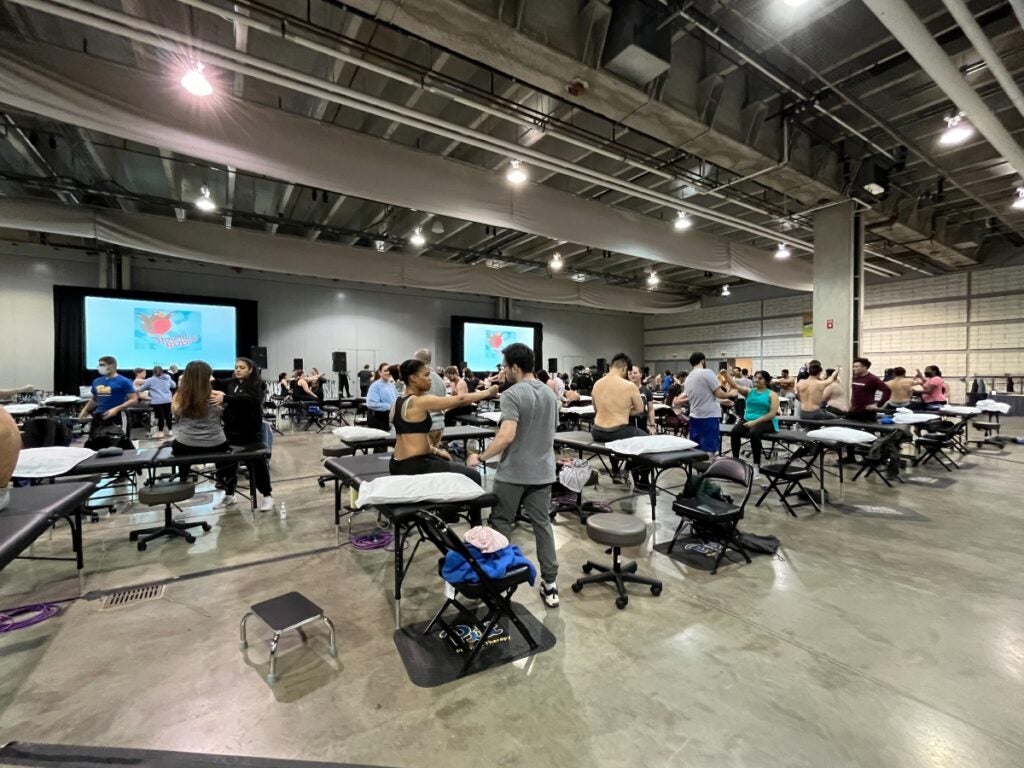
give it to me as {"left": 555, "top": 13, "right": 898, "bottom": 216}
{"left": 212, "top": 357, "right": 273, "bottom": 512}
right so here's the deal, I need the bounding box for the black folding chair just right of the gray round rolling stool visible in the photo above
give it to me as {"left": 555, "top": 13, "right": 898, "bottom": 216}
{"left": 669, "top": 456, "right": 754, "bottom": 575}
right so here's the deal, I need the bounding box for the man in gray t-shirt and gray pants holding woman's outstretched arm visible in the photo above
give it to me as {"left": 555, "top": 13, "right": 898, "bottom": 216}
{"left": 466, "top": 343, "right": 558, "bottom": 608}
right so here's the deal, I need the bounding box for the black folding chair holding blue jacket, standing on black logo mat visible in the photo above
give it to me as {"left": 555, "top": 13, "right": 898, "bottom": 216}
{"left": 416, "top": 510, "right": 538, "bottom": 675}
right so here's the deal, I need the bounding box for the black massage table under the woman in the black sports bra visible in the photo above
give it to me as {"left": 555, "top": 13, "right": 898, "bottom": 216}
{"left": 324, "top": 454, "right": 497, "bottom": 629}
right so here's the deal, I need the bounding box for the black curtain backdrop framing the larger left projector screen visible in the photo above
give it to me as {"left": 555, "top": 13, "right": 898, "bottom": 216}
{"left": 53, "top": 286, "right": 259, "bottom": 394}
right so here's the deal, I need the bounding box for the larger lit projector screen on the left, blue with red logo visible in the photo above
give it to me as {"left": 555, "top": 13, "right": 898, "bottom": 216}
{"left": 82, "top": 296, "right": 238, "bottom": 371}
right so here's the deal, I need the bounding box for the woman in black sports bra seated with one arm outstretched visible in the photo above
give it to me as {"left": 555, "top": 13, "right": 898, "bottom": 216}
{"left": 390, "top": 359, "right": 498, "bottom": 484}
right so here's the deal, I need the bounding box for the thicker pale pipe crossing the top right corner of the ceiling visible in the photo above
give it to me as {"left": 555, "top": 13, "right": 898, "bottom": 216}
{"left": 864, "top": 0, "right": 1024, "bottom": 181}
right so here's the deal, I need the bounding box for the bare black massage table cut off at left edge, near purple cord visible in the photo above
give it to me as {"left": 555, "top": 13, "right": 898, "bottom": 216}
{"left": 0, "top": 482, "right": 95, "bottom": 588}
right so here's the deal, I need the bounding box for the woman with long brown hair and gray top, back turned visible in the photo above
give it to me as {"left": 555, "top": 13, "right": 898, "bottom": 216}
{"left": 171, "top": 360, "right": 238, "bottom": 507}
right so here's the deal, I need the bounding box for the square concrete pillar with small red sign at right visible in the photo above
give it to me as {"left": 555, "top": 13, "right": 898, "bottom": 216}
{"left": 813, "top": 201, "right": 864, "bottom": 396}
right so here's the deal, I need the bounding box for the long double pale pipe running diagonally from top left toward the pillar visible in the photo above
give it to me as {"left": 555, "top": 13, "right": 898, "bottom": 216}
{"left": 11, "top": 0, "right": 814, "bottom": 257}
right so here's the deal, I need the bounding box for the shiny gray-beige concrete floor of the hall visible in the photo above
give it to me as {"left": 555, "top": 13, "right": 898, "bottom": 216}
{"left": 0, "top": 420, "right": 1024, "bottom": 768}
